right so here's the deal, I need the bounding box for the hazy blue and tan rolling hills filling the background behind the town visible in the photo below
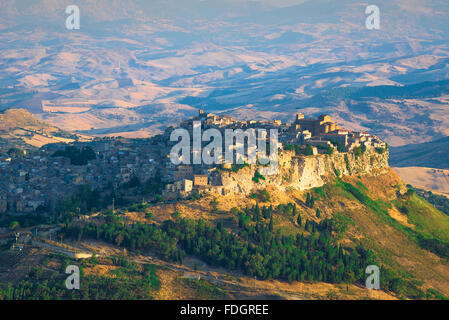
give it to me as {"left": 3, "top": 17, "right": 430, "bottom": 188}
{"left": 0, "top": 0, "right": 449, "bottom": 146}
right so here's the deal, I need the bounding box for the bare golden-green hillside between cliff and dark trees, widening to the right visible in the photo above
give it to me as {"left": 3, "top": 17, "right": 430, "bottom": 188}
{"left": 154, "top": 171, "right": 449, "bottom": 298}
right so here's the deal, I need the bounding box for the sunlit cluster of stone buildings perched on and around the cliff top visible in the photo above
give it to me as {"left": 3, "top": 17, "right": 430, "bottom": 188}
{"left": 159, "top": 110, "right": 388, "bottom": 199}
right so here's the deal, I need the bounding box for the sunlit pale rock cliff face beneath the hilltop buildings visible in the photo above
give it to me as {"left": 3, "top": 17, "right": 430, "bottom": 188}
{"left": 217, "top": 148, "right": 389, "bottom": 194}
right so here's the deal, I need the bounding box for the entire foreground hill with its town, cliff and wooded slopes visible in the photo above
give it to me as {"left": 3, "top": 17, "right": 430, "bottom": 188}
{"left": 0, "top": 111, "right": 449, "bottom": 299}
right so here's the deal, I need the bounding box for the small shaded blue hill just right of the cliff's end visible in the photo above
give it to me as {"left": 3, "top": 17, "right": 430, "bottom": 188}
{"left": 390, "top": 137, "right": 449, "bottom": 169}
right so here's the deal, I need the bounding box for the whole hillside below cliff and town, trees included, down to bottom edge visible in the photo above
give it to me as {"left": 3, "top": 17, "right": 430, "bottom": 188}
{"left": 0, "top": 162, "right": 449, "bottom": 299}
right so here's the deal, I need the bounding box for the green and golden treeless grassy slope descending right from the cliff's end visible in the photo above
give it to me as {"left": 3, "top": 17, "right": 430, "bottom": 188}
{"left": 320, "top": 171, "right": 449, "bottom": 296}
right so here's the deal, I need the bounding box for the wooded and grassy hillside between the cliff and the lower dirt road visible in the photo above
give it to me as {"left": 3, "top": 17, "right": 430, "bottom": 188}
{"left": 50, "top": 171, "right": 449, "bottom": 299}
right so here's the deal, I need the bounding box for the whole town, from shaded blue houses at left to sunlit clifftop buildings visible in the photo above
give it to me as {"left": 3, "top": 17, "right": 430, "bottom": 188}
{"left": 0, "top": 110, "right": 386, "bottom": 213}
